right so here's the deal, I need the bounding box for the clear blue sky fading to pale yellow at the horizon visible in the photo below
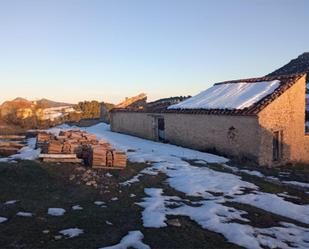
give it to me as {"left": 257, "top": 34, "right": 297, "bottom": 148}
{"left": 0, "top": 0, "right": 309, "bottom": 103}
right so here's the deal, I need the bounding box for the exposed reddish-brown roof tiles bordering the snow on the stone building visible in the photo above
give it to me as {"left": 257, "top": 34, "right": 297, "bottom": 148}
{"left": 113, "top": 73, "right": 305, "bottom": 116}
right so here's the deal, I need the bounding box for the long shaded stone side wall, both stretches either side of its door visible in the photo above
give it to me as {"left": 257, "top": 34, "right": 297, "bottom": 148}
{"left": 111, "top": 112, "right": 259, "bottom": 162}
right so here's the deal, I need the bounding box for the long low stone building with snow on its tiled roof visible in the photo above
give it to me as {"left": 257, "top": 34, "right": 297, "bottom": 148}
{"left": 111, "top": 74, "right": 309, "bottom": 166}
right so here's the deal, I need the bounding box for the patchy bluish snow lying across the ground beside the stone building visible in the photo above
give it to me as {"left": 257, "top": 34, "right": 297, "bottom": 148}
{"left": 1, "top": 124, "right": 309, "bottom": 248}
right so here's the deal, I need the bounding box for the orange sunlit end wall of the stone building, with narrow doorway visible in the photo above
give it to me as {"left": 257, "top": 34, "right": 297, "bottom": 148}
{"left": 258, "top": 76, "right": 309, "bottom": 165}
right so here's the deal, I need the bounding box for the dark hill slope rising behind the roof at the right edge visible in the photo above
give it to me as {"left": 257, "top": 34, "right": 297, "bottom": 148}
{"left": 267, "top": 52, "right": 309, "bottom": 83}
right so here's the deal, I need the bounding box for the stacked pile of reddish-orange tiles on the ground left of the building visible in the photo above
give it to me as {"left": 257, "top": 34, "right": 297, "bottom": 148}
{"left": 36, "top": 130, "right": 127, "bottom": 169}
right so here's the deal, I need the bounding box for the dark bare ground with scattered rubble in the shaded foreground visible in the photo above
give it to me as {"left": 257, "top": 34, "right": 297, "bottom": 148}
{"left": 0, "top": 161, "right": 309, "bottom": 249}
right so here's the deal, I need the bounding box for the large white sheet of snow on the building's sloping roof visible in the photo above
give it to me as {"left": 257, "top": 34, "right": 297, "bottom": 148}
{"left": 168, "top": 80, "right": 280, "bottom": 110}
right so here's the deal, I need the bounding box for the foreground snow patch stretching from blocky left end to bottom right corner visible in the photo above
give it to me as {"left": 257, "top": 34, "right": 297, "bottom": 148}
{"left": 139, "top": 189, "right": 309, "bottom": 249}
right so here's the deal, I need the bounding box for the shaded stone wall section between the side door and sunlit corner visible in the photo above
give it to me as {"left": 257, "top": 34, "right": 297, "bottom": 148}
{"left": 165, "top": 113, "right": 259, "bottom": 162}
